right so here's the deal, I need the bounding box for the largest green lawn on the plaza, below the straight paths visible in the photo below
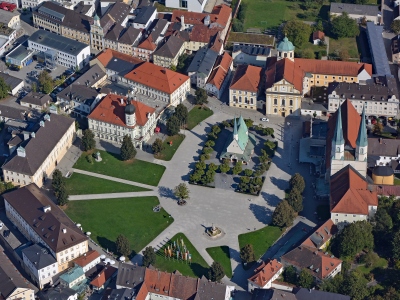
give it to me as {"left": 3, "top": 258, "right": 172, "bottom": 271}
{"left": 65, "top": 197, "right": 174, "bottom": 255}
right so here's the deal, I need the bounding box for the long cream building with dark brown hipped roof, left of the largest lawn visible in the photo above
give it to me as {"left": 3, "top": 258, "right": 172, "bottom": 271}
{"left": 3, "top": 184, "right": 88, "bottom": 273}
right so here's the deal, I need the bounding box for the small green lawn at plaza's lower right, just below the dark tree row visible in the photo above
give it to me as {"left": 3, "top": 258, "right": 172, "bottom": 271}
{"left": 239, "top": 226, "right": 282, "bottom": 259}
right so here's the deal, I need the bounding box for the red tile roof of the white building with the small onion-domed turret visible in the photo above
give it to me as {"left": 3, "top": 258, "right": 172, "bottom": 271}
{"left": 88, "top": 94, "right": 156, "bottom": 127}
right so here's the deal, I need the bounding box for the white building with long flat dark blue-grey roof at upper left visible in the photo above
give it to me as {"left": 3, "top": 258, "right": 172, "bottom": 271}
{"left": 28, "top": 30, "right": 90, "bottom": 69}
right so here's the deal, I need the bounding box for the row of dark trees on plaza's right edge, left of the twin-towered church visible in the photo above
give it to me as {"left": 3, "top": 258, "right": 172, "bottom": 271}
{"left": 272, "top": 173, "right": 305, "bottom": 227}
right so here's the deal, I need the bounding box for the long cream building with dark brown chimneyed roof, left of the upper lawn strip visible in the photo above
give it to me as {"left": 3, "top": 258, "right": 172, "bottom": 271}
{"left": 3, "top": 114, "right": 75, "bottom": 187}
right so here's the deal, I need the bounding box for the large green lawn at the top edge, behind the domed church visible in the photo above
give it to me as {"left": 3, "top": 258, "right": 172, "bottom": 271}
{"left": 243, "top": 0, "right": 329, "bottom": 31}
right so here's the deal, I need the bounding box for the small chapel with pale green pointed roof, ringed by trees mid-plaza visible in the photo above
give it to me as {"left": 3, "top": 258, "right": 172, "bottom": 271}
{"left": 221, "top": 116, "right": 256, "bottom": 164}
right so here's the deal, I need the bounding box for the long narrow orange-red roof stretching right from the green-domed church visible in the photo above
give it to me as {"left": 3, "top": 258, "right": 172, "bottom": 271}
{"left": 294, "top": 58, "right": 372, "bottom": 77}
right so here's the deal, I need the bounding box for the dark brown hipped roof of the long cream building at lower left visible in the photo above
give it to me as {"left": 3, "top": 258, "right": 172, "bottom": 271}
{"left": 3, "top": 185, "right": 88, "bottom": 253}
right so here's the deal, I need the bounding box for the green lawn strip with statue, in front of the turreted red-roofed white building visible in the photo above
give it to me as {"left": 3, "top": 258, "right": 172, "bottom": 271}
{"left": 74, "top": 150, "right": 165, "bottom": 186}
